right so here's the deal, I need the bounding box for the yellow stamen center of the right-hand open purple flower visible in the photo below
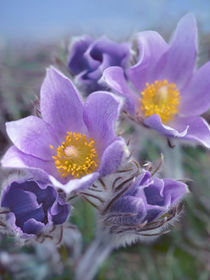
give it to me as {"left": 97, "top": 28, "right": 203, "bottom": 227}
{"left": 139, "top": 80, "right": 180, "bottom": 123}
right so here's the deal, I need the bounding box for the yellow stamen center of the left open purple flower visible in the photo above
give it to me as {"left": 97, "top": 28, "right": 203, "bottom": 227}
{"left": 50, "top": 132, "right": 98, "bottom": 178}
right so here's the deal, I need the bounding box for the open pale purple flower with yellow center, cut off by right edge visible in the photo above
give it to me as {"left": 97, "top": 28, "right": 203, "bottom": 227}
{"left": 104, "top": 14, "right": 210, "bottom": 148}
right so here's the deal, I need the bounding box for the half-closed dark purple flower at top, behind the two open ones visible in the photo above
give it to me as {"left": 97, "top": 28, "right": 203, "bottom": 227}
{"left": 68, "top": 36, "right": 129, "bottom": 93}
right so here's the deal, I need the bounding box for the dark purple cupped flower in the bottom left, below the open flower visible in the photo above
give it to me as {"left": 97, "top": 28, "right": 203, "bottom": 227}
{"left": 1, "top": 180, "right": 69, "bottom": 237}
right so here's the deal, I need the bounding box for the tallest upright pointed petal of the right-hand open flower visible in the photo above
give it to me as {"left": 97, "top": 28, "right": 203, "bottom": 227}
{"left": 154, "top": 14, "right": 197, "bottom": 89}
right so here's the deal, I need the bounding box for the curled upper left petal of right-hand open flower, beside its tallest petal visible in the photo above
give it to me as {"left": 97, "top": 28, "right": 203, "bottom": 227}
{"left": 128, "top": 31, "right": 168, "bottom": 92}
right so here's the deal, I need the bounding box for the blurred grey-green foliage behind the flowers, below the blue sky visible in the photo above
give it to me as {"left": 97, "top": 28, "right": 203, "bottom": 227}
{"left": 0, "top": 36, "right": 210, "bottom": 280}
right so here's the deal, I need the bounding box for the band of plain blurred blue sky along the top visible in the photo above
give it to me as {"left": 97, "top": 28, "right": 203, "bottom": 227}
{"left": 0, "top": 0, "right": 210, "bottom": 42}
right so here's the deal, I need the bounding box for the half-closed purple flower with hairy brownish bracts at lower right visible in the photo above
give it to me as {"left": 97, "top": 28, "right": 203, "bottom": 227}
{"left": 102, "top": 170, "right": 188, "bottom": 247}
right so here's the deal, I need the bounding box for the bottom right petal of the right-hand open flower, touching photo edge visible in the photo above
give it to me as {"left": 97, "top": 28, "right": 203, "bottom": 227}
{"left": 174, "top": 117, "right": 210, "bottom": 148}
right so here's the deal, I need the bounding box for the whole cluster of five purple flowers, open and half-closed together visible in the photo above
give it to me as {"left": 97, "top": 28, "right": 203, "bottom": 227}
{"left": 0, "top": 14, "right": 210, "bottom": 246}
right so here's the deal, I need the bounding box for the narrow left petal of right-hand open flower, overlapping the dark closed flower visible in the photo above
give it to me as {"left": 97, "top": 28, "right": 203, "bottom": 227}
{"left": 102, "top": 66, "right": 140, "bottom": 115}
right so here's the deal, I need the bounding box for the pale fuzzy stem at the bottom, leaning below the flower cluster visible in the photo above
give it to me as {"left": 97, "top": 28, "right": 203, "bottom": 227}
{"left": 75, "top": 234, "right": 113, "bottom": 280}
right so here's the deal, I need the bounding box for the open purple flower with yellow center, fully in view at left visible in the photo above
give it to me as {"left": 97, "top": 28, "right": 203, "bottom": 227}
{"left": 2, "top": 68, "right": 124, "bottom": 192}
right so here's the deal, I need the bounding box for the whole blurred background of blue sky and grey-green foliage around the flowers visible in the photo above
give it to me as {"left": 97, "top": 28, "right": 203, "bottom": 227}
{"left": 0, "top": 0, "right": 210, "bottom": 280}
